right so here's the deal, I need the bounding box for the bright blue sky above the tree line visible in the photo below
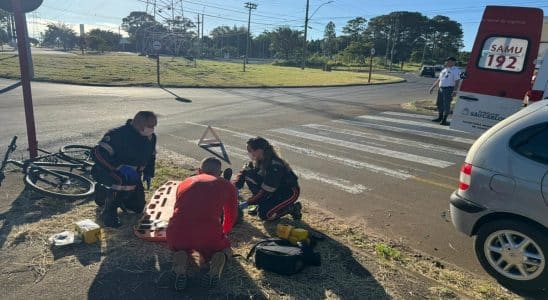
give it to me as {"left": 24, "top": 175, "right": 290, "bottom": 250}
{"left": 23, "top": 0, "right": 548, "bottom": 51}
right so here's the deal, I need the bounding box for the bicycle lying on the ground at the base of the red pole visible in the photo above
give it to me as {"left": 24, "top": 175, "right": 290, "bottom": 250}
{"left": 0, "top": 136, "right": 95, "bottom": 199}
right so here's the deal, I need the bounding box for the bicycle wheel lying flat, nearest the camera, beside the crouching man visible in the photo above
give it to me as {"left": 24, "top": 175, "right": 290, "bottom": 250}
{"left": 25, "top": 168, "right": 95, "bottom": 199}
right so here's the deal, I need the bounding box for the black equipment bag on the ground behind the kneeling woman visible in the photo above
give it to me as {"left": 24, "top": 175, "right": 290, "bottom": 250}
{"left": 247, "top": 239, "right": 321, "bottom": 275}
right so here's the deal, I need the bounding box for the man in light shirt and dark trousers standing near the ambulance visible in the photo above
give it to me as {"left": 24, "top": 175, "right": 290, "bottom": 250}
{"left": 429, "top": 57, "right": 461, "bottom": 126}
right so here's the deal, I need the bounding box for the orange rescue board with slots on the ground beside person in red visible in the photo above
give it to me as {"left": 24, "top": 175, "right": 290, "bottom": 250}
{"left": 133, "top": 181, "right": 180, "bottom": 242}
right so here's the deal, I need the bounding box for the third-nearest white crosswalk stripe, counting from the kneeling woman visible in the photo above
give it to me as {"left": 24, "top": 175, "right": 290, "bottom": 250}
{"left": 271, "top": 128, "right": 454, "bottom": 168}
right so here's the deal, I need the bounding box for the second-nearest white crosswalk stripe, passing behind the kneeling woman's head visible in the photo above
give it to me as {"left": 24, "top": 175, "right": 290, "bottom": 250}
{"left": 187, "top": 122, "right": 414, "bottom": 180}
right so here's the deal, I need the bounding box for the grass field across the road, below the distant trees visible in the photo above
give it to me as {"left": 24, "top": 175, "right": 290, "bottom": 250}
{"left": 0, "top": 53, "right": 402, "bottom": 87}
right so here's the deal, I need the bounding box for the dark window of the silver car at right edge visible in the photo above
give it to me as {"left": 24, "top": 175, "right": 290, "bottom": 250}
{"left": 510, "top": 123, "right": 548, "bottom": 164}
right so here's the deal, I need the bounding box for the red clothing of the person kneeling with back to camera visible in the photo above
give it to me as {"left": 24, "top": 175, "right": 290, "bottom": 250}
{"left": 166, "top": 174, "right": 238, "bottom": 256}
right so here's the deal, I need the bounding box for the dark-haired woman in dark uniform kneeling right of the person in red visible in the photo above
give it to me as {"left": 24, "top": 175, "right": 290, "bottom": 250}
{"left": 233, "top": 137, "right": 302, "bottom": 220}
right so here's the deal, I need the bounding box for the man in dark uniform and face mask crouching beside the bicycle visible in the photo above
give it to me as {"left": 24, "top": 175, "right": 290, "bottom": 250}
{"left": 91, "top": 111, "right": 158, "bottom": 227}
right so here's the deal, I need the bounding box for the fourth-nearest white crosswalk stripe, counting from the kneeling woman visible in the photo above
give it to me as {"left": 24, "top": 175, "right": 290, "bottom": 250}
{"left": 303, "top": 124, "right": 466, "bottom": 156}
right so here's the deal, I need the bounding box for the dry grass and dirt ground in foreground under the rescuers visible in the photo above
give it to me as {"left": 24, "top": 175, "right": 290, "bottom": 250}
{"left": 0, "top": 163, "right": 513, "bottom": 299}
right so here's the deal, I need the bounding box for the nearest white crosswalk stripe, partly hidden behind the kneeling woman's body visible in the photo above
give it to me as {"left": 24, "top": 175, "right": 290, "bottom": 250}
{"left": 220, "top": 145, "right": 372, "bottom": 194}
